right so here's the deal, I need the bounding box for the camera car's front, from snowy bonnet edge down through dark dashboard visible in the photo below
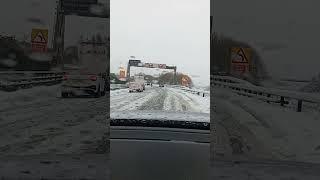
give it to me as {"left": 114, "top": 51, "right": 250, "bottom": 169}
{"left": 110, "top": 111, "right": 210, "bottom": 180}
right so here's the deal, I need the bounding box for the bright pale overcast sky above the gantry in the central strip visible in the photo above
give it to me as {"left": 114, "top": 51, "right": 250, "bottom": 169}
{"left": 110, "top": 0, "right": 210, "bottom": 85}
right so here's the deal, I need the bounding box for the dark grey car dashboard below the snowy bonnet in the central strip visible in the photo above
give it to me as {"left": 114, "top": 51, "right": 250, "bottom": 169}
{"left": 110, "top": 120, "right": 210, "bottom": 180}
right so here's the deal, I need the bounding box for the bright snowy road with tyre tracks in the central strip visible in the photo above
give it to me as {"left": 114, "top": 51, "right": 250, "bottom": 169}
{"left": 110, "top": 86, "right": 210, "bottom": 113}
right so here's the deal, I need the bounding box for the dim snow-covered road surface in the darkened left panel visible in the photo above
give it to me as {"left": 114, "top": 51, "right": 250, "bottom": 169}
{"left": 0, "top": 85, "right": 109, "bottom": 155}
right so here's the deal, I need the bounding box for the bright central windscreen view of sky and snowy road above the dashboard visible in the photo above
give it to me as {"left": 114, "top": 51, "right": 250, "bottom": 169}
{"left": 110, "top": 0, "right": 210, "bottom": 127}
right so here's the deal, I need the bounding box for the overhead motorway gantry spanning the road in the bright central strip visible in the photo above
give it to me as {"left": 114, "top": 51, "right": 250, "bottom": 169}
{"left": 127, "top": 59, "right": 178, "bottom": 84}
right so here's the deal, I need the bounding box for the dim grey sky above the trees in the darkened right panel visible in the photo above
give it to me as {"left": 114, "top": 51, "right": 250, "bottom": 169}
{"left": 211, "top": 0, "right": 320, "bottom": 79}
